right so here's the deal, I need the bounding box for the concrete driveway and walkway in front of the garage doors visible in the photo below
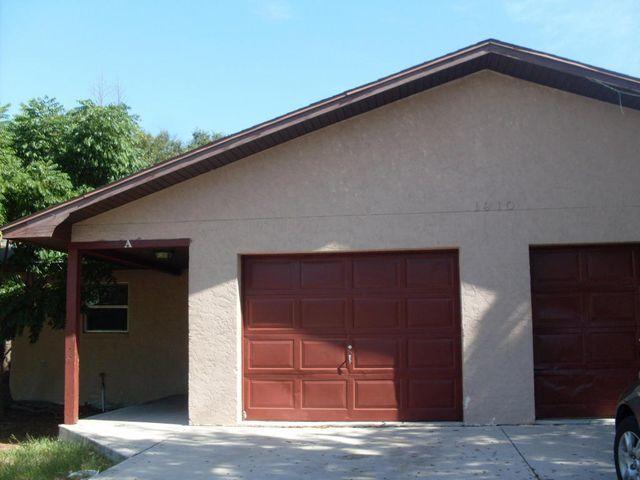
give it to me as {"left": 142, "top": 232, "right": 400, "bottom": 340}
{"left": 62, "top": 400, "right": 615, "bottom": 480}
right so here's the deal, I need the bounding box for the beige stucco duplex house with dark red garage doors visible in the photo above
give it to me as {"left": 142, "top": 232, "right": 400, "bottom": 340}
{"left": 2, "top": 40, "right": 640, "bottom": 424}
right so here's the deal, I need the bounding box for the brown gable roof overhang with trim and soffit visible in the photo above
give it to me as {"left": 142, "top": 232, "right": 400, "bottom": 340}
{"left": 0, "top": 39, "right": 640, "bottom": 249}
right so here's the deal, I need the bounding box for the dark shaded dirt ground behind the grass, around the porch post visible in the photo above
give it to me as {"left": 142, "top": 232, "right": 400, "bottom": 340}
{"left": 0, "top": 402, "right": 99, "bottom": 451}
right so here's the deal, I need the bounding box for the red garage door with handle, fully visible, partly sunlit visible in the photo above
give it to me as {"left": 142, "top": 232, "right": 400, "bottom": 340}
{"left": 243, "top": 252, "right": 462, "bottom": 421}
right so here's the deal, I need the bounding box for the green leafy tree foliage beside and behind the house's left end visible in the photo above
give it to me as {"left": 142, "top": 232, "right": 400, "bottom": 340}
{"left": 0, "top": 97, "right": 225, "bottom": 342}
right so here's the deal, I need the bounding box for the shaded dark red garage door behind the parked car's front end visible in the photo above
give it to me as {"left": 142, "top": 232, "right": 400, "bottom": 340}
{"left": 531, "top": 245, "right": 640, "bottom": 418}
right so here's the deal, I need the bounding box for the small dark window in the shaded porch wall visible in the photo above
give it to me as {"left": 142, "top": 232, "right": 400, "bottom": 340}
{"left": 84, "top": 283, "right": 129, "bottom": 333}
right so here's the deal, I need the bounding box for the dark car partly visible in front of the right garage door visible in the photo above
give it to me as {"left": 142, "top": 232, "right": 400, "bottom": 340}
{"left": 613, "top": 381, "right": 640, "bottom": 480}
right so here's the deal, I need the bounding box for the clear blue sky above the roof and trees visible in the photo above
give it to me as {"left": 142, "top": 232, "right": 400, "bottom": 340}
{"left": 0, "top": 0, "right": 640, "bottom": 139}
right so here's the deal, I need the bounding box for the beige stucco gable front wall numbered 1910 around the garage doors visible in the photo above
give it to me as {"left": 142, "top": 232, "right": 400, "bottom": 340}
{"left": 73, "top": 72, "right": 640, "bottom": 424}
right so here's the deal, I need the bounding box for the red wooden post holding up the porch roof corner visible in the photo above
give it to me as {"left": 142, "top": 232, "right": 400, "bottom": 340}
{"left": 64, "top": 247, "right": 82, "bottom": 425}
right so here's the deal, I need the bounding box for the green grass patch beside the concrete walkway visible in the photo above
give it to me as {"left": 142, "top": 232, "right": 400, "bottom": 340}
{"left": 0, "top": 438, "right": 113, "bottom": 480}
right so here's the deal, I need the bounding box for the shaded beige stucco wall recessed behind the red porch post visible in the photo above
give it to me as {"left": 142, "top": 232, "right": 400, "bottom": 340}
{"left": 11, "top": 270, "right": 188, "bottom": 406}
